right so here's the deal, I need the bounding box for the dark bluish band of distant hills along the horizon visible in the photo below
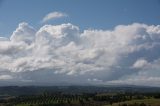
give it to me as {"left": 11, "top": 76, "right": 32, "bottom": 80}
{"left": 0, "top": 86, "right": 160, "bottom": 96}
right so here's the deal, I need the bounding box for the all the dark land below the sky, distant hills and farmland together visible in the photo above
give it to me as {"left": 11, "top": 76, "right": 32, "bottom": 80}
{"left": 0, "top": 86, "right": 160, "bottom": 106}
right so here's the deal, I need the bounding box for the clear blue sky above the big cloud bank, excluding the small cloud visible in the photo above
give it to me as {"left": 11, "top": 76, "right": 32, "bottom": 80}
{"left": 0, "top": 0, "right": 160, "bottom": 37}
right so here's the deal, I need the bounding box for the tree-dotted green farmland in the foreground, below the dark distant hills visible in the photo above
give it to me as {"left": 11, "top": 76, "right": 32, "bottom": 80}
{"left": 0, "top": 88, "right": 160, "bottom": 106}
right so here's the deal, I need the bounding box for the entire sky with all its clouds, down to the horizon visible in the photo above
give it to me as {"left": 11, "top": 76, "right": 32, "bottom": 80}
{"left": 0, "top": 0, "right": 160, "bottom": 86}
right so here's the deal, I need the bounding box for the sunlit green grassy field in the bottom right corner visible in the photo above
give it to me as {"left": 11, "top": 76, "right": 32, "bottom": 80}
{"left": 105, "top": 99, "right": 160, "bottom": 106}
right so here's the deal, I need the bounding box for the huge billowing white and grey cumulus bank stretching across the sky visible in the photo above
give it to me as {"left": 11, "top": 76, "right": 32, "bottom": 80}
{"left": 0, "top": 22, "right": 160, "bottom": 86}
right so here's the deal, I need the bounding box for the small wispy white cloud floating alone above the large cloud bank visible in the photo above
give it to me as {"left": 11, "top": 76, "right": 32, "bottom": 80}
{"left": 42, "top": 11, "right": 68, "bottom": 22}
